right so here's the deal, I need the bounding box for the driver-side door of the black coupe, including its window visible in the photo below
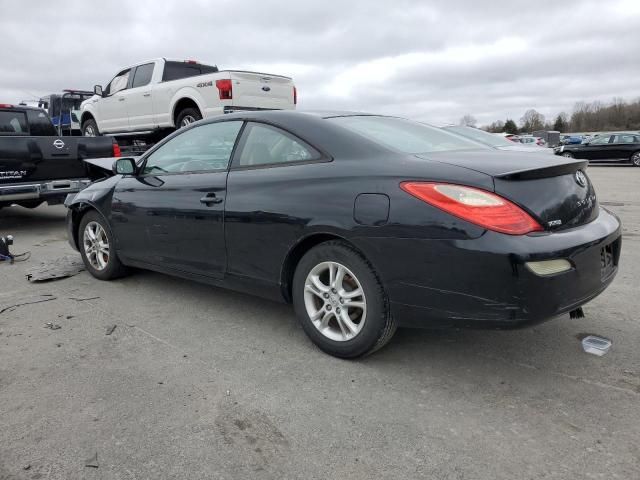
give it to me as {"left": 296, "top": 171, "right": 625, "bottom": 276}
{"left": 112, "top": 120, "right": 242, "bottom": 278}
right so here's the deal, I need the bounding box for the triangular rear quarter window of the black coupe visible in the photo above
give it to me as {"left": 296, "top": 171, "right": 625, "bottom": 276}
{"left": 239, "top": 123, "right": 322, "bottom": 167}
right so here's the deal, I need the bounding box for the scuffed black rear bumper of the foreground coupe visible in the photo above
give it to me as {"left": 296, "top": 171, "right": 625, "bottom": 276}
{"left": 356, "top": 208, "right": 621, "bottom": 328}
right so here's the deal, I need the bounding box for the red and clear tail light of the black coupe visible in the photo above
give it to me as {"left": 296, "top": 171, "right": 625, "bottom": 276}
{"left": 400, "top": 182, "right": 542, "bottom": 235}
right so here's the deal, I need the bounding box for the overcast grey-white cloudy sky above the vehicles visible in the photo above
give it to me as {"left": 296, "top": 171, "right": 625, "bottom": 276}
{"left": 0, "top": 0, "right": 640, "bottom": 124}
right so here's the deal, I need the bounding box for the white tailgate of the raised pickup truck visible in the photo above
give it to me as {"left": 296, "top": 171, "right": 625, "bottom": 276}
{"left": 228, "top": 70, "right": 295, "bottom": 110}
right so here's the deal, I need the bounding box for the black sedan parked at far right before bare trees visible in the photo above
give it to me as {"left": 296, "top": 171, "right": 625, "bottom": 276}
{"left": 554, "top": 133, "right": 640, "bottom": 167}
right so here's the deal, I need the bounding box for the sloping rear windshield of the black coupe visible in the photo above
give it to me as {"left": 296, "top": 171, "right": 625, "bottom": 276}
{"left": 328, "top": 115, "right": 483, "bottom": 154}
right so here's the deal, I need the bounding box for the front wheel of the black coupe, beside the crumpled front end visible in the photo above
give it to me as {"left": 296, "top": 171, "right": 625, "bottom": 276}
{"left": 77, "top": 210, "right": 127, "bottom": 280}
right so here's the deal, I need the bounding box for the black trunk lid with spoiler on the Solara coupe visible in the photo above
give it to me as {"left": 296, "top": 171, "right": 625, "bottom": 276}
{"left": 419, "top": 151, "right": 599, "bottom": 230}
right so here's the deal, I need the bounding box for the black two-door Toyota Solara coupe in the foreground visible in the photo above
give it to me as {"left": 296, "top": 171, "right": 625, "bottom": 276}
{"left": 66, "top": 111, "right": 621, "bottom": 358}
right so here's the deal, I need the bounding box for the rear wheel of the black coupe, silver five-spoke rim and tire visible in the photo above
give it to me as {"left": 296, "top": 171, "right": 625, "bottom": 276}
{"left": 292, "top": 241, "right": 396, "bottom": 358}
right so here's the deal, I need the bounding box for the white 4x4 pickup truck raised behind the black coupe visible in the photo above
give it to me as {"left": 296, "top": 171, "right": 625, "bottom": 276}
{"left": 80, "top": 58, "right": 297, "bottom": 136}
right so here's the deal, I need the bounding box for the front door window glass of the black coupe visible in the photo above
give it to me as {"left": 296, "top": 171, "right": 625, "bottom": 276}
{"left": 142, "top": 121, "right": 242, "bottom": 175}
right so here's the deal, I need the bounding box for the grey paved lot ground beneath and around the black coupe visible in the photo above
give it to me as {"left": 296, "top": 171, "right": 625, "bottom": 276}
{"left": 0, "top": 167, "right": 640, "bottom": 480}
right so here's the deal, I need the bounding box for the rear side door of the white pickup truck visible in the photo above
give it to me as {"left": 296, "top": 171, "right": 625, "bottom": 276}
{"left": 122, "top": 62, "right": 155, "bottom": 130}
